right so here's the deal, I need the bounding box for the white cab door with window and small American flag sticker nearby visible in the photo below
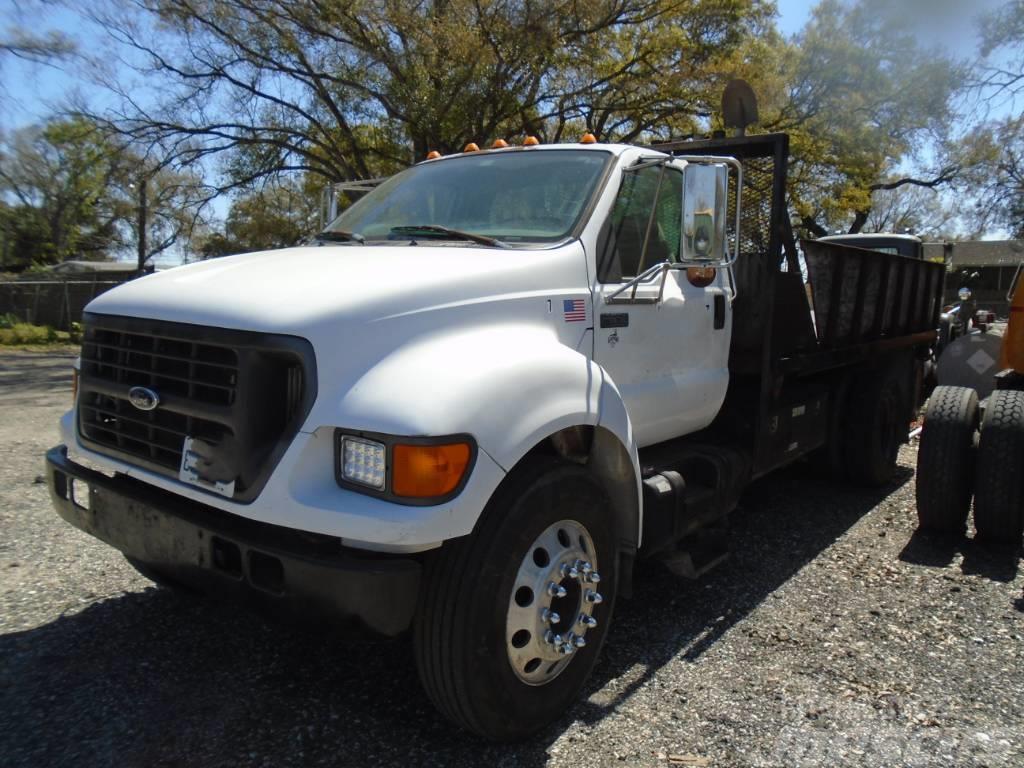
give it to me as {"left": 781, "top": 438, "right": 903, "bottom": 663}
{"left": 594, "top": 163, "right": 731, "bottom": 445}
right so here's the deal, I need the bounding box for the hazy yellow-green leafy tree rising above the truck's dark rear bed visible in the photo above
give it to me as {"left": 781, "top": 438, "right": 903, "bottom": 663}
{"left": 752, "top": 0, "right": 965, "bottom": 236}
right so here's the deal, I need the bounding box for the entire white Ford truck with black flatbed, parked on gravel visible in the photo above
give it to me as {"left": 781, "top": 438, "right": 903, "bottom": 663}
{"left": 47, "top": 135, "right": 943, "bottom": 739}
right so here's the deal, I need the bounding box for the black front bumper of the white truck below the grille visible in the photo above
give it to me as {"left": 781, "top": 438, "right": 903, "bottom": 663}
{"left": 46, "top": 445, "right": 421, "bottom": 636}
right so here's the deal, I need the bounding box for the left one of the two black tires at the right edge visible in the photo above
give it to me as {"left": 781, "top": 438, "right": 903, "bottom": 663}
{"left": 916, "top": 386, "right": 978, "bottom": 537}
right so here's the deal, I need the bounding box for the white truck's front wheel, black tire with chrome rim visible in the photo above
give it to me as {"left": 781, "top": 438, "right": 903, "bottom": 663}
{"left": 414, "top": 460, "right": 617, "bottom": 741}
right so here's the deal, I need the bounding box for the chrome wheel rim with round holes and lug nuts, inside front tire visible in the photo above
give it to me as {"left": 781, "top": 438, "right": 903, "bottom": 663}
{"left": 505, "top": 520, "right": 603, "bottom": 685}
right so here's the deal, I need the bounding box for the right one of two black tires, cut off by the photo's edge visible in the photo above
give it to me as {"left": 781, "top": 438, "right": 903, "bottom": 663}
{"left": 974, "top": 390, "right": 1024, "bottom": 550}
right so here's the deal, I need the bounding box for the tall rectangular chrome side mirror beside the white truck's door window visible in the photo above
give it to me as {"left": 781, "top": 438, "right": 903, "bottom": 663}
{"left": 683, "top": 163, "right": 729, "bottom": 264}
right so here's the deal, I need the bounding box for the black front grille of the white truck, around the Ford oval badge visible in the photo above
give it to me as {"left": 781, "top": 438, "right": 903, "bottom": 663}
{"left": 78, "top": 314, "right": 314, "bottom": 501}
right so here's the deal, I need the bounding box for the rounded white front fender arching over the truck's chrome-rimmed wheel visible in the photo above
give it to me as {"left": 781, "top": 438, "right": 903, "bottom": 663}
{"left": 317, "top": 325, "right": 642, "bottom": 544}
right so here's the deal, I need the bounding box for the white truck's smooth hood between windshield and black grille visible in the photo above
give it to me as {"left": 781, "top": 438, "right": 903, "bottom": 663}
{"left": 92, "top": 243, "right": 587, "bottom": 333}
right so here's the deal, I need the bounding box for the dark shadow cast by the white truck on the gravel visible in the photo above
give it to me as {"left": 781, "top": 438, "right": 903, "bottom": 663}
{"left": 0, "top": 460, "right": 912, "bottom": 768}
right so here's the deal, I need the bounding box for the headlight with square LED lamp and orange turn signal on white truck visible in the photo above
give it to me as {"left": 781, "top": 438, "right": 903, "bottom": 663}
{"left": 335, "top": 429, "right": 476, "bottom": 505}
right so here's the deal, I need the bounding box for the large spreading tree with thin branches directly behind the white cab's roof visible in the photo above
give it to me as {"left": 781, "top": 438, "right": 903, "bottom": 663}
{"left": 81, "top": 0, "right": 772, "bottom": 190}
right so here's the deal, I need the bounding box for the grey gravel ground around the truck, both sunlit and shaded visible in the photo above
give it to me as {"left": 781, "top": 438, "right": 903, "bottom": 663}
{"left": 0, "top": 351, "right": 1024, "bottom": 768}
